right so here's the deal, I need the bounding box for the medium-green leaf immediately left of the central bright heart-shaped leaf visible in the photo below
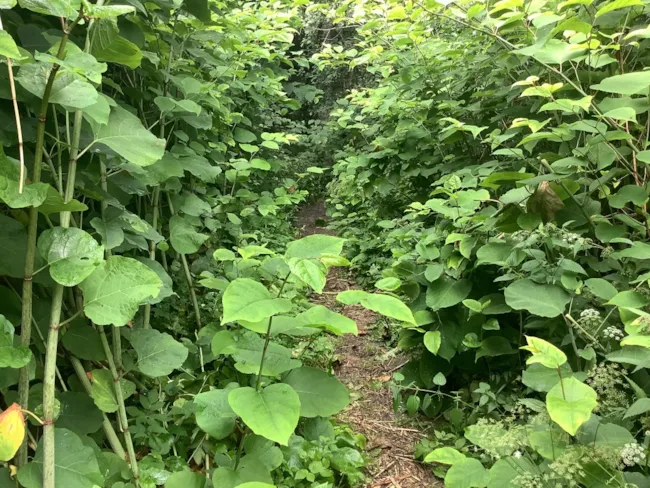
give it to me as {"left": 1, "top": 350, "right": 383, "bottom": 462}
{"left": 194, "top": 383, "right": 237, "bottom": 440}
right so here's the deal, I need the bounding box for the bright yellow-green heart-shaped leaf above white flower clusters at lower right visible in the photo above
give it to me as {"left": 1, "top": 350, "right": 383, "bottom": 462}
{"left": 546, "top": 377, "right": 598, "bottom": 435}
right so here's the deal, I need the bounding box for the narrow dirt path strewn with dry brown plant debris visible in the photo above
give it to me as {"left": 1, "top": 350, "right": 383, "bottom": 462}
{"left": 296, "top": 201, "right": 442, "bottom": 488}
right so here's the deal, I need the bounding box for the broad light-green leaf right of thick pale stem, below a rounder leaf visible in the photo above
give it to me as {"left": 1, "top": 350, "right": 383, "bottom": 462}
{"left": 79, "top": 256, "right": 162, "bottom": 327}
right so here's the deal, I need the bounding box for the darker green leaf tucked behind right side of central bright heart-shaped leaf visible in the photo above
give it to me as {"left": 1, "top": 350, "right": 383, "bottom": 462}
{"left": 284, "top": 366, "right": 350, "bottom": 417}
